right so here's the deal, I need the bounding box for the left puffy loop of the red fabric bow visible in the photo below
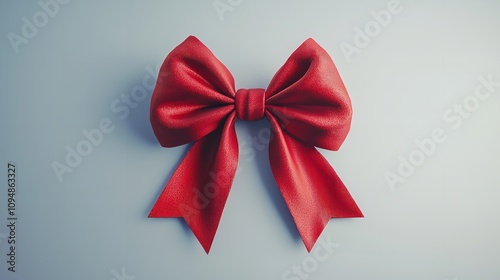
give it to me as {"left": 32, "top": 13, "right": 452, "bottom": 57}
{"left": 150, "top": 36, "right": 235, "bottom": 147}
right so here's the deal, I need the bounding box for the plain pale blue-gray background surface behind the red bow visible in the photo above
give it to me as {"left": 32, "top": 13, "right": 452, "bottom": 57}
{"left": 0, "top": 0, "right": 500, "bottom": 280}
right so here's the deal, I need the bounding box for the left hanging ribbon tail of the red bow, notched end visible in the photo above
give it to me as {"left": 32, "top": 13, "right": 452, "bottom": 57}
{"left": 149, "top": 112, "right": 238, "bottom": 254}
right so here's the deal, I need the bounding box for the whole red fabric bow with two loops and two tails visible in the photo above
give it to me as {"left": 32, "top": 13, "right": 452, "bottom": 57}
{"left": 149, "top": 36, "right": 363, "bottom": 253}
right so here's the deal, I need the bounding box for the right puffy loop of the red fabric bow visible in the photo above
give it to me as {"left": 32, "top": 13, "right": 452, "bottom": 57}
{"left": 266, "top": 39, "right": 352, "bottom": 150}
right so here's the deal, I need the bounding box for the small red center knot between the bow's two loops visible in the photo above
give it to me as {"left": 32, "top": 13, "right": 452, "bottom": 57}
{"left": 234, "top": 88, "right": 265, "bottom": 121}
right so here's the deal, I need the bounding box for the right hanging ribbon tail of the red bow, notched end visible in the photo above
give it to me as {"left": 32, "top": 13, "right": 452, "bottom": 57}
{"left": 268, "top": 115, "right": 363, "bottom": 252}
